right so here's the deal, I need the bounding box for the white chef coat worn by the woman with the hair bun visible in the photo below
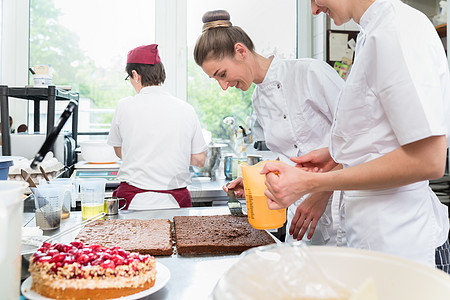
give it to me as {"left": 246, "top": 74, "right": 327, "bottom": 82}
{"left": 252, "top": 57, "right": 344, "bottom": 245}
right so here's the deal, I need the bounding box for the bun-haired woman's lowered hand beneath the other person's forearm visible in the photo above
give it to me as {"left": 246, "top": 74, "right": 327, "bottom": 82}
{"left": 289, "top": 192, "right": 332, "bottom": 240}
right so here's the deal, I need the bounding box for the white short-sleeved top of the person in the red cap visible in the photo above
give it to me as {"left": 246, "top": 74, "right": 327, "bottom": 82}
{"left": 108, "top": 86, "right": 207, "bottom": 190}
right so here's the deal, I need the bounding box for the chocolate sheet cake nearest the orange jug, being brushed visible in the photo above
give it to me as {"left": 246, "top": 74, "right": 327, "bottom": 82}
{"left": 173, "top": 215, "right": 275, "bottom": 255}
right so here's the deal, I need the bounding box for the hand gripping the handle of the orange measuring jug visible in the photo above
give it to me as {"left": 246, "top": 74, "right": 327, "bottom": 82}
{"left": 261, "top": 162, "right": 317, "bottom": 209}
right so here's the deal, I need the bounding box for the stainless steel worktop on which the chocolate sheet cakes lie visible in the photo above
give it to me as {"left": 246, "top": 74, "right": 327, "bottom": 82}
{"left": 24, "top": 206, "right": 246, "bottom": 299}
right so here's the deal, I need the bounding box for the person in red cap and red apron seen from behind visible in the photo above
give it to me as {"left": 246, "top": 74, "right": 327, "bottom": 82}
{"left": 108, "top": 44, "right": 207, "bottom": 210}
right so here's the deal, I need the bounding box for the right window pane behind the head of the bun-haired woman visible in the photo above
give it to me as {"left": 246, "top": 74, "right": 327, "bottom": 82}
{"left": 187, "top": 0, "right": 297, "bottom": 140}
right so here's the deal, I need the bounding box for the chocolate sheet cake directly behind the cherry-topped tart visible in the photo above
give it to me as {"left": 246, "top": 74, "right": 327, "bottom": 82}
{"left": 76, "top": 219, "right": 173, "bottom": 255}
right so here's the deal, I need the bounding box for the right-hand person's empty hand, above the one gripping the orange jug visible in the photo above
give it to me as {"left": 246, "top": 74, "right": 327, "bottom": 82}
{"left": 291, "top": 148, "right": 337, "bottom": 172}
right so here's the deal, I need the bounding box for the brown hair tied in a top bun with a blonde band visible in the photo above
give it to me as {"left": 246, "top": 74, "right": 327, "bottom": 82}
{"left": 194, "top": 10, "right": 255, "bottom": 66}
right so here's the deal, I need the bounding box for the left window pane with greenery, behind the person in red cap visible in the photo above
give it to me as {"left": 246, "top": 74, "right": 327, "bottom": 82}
{"left": 29, "top": 0, "right": 155, "bottom": 139}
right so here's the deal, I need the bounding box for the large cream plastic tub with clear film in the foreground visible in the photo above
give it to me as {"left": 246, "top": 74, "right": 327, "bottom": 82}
{"left": 212, "top": 243, "right": 450, "bottom": 300}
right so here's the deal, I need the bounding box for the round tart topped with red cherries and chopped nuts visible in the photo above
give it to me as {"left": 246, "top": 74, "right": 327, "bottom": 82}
{"left": 29, "top": 242, "right": 156, "bottom": 299}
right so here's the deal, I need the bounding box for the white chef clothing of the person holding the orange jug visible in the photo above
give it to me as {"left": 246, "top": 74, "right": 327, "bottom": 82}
{"left": 330, "top": 0, "right": 450, "bottom": 266}
